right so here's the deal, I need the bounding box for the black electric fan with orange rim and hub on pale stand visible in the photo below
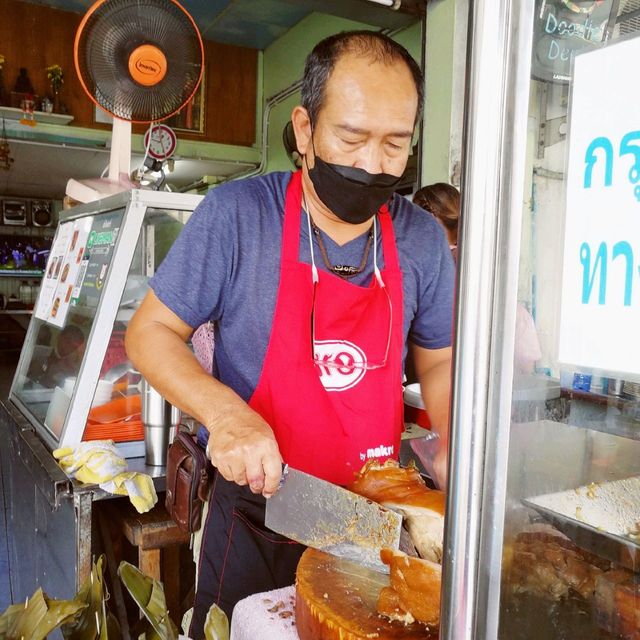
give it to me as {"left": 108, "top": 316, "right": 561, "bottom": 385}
{"left": 66, "top": 0, "right": 204, "bottom": 202}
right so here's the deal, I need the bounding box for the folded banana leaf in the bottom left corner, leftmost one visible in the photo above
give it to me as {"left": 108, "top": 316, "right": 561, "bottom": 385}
{"left": 6, "top": 589, "right": 87, "bottom": 640}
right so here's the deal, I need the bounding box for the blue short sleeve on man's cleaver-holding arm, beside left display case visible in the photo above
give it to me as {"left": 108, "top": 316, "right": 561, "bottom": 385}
{"left": 149, "top": 187, "right": 237, "bottom": 328}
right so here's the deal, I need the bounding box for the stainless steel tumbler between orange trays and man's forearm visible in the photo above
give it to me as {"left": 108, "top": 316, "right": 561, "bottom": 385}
{"left": 140, "top": 378, "right": 181, "bottom": 467}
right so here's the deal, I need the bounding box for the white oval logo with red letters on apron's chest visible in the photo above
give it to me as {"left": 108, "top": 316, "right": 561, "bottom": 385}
{"left": 314, "top": 340, "right": 367, "bottom": 391}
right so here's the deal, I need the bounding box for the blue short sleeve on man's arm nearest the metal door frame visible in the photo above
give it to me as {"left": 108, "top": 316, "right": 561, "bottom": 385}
{"left": 409, "top": 233, "right": 455, "bottom": 349}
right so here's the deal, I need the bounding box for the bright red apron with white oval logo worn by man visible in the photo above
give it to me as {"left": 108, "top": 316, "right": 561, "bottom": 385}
{"left": 249, "top": 172, "right": 403, "bottom": 485}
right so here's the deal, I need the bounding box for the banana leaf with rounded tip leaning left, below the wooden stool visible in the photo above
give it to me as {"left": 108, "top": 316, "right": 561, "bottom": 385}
{"left": 118, "top": 560, "right": 178, "bottom": 640}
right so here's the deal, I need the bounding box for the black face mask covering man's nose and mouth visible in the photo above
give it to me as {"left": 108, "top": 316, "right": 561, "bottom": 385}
{"left": 305, "top": 155, "right": 402, "bottom": 224}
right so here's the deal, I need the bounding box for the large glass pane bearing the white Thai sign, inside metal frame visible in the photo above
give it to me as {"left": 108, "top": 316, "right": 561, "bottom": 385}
{"left": 499, "top": 5, "right": 640, "bottom": 640}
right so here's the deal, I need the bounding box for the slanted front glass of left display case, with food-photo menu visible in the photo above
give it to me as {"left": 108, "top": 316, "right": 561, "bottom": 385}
{"left": 12, "top": 209, "right": 124, "bottom": 437}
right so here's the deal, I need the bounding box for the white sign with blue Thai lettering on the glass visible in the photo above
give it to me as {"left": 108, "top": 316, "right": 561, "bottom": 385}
{"left": 558, "top": 38, "right": 640, "bottom": 374}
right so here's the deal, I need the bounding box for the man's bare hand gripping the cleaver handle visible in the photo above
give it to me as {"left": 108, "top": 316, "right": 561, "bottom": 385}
{"left": 207, "top": 406, "right": 282, "bottom": 498}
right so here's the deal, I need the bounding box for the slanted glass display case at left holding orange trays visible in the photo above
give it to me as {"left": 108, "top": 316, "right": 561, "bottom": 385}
{"left": 10, "top": 190, "right": 202, "bottom": 457}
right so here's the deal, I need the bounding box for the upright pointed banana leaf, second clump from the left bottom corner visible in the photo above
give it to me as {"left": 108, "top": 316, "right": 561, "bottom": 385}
{"left": 61, "top": 555, "right": 120, "bottom": 640}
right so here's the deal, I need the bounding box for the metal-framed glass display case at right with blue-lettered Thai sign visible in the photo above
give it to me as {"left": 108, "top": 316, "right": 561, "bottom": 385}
{"left": 441, "top": 0, "right": 640, "bottom": 640}
